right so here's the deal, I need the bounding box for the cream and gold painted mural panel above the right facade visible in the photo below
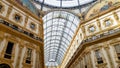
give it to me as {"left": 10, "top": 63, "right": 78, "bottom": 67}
{"left": 86, "top": 0, "right": 120, "bottom": 19}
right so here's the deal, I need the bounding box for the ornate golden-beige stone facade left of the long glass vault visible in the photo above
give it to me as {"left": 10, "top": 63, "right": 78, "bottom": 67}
{"left": 0, "top": 0, "right": 44, "bottom": 68}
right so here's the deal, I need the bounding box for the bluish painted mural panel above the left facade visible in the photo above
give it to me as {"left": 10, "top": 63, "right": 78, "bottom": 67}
{"left": 16, "top": 0, "right": 39, "bottom": 16}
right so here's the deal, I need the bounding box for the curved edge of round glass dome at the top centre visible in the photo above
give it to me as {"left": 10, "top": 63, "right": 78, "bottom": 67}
{"left": 34, "top": 0, "right": 96, "bottom": 8}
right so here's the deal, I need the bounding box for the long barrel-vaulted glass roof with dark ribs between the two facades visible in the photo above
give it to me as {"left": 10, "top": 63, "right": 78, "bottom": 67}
{"left": 43, "top": 11, "right": 80, "bottom": 66}
